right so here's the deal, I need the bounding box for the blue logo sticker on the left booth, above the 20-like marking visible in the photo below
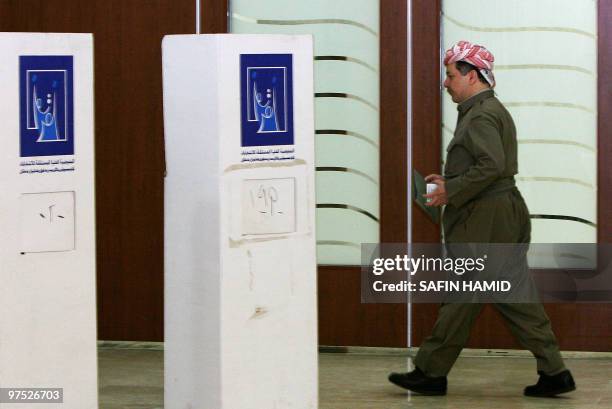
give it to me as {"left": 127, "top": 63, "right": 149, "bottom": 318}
{"left": 19, "top": 56, "right": 74, "bottom": 157}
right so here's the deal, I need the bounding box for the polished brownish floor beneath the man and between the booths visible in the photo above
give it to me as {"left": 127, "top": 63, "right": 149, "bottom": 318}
{"left": 98, "top": 344, "right": 612, "bottom": 409}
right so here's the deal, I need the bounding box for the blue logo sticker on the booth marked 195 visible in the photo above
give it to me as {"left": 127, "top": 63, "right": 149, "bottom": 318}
{"left": 240, "top": 54, "right": 293, "bottom": 146}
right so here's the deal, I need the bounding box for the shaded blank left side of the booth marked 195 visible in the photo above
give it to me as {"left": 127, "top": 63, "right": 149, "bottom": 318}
{"left": 162, "top": 36, "right": 222, "bottom": 409}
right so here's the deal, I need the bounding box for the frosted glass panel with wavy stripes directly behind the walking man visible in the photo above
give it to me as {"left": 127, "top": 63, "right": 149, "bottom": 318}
{"left": 442, "top": 0, "right": 597, "bottom": 249}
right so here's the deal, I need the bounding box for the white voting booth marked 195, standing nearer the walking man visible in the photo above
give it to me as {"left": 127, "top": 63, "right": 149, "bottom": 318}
{"left": 162, "top": 35, "right": 318, "bottom": 409}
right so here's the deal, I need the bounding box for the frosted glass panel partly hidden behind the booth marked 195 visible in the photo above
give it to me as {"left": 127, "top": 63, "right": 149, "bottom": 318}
{"left": 230, "top": 0, "right": 380, "bottom": 265}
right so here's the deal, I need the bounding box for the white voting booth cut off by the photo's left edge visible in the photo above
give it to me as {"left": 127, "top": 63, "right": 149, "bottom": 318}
{"left": 0, "top": 33, "right": 98, "bottom": 409}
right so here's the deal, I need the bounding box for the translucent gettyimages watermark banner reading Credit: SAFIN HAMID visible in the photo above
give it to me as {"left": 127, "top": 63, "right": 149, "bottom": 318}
{"left": 361, "top": 243, "right": 612, "bottom": 303}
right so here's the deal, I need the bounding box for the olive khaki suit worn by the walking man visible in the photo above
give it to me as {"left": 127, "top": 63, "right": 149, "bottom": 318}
{"left": 415, "top": 90, "right": 565, "bottom": 376}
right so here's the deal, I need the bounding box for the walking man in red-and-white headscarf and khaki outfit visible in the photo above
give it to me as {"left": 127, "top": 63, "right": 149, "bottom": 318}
{"left": 389, "top": 41, "right": 576, "bottom": 397}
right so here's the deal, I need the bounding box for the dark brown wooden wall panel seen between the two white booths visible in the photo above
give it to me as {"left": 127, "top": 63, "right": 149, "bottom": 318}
{"left": 0, "top": 0, "right": 195, "bottom": 341}
